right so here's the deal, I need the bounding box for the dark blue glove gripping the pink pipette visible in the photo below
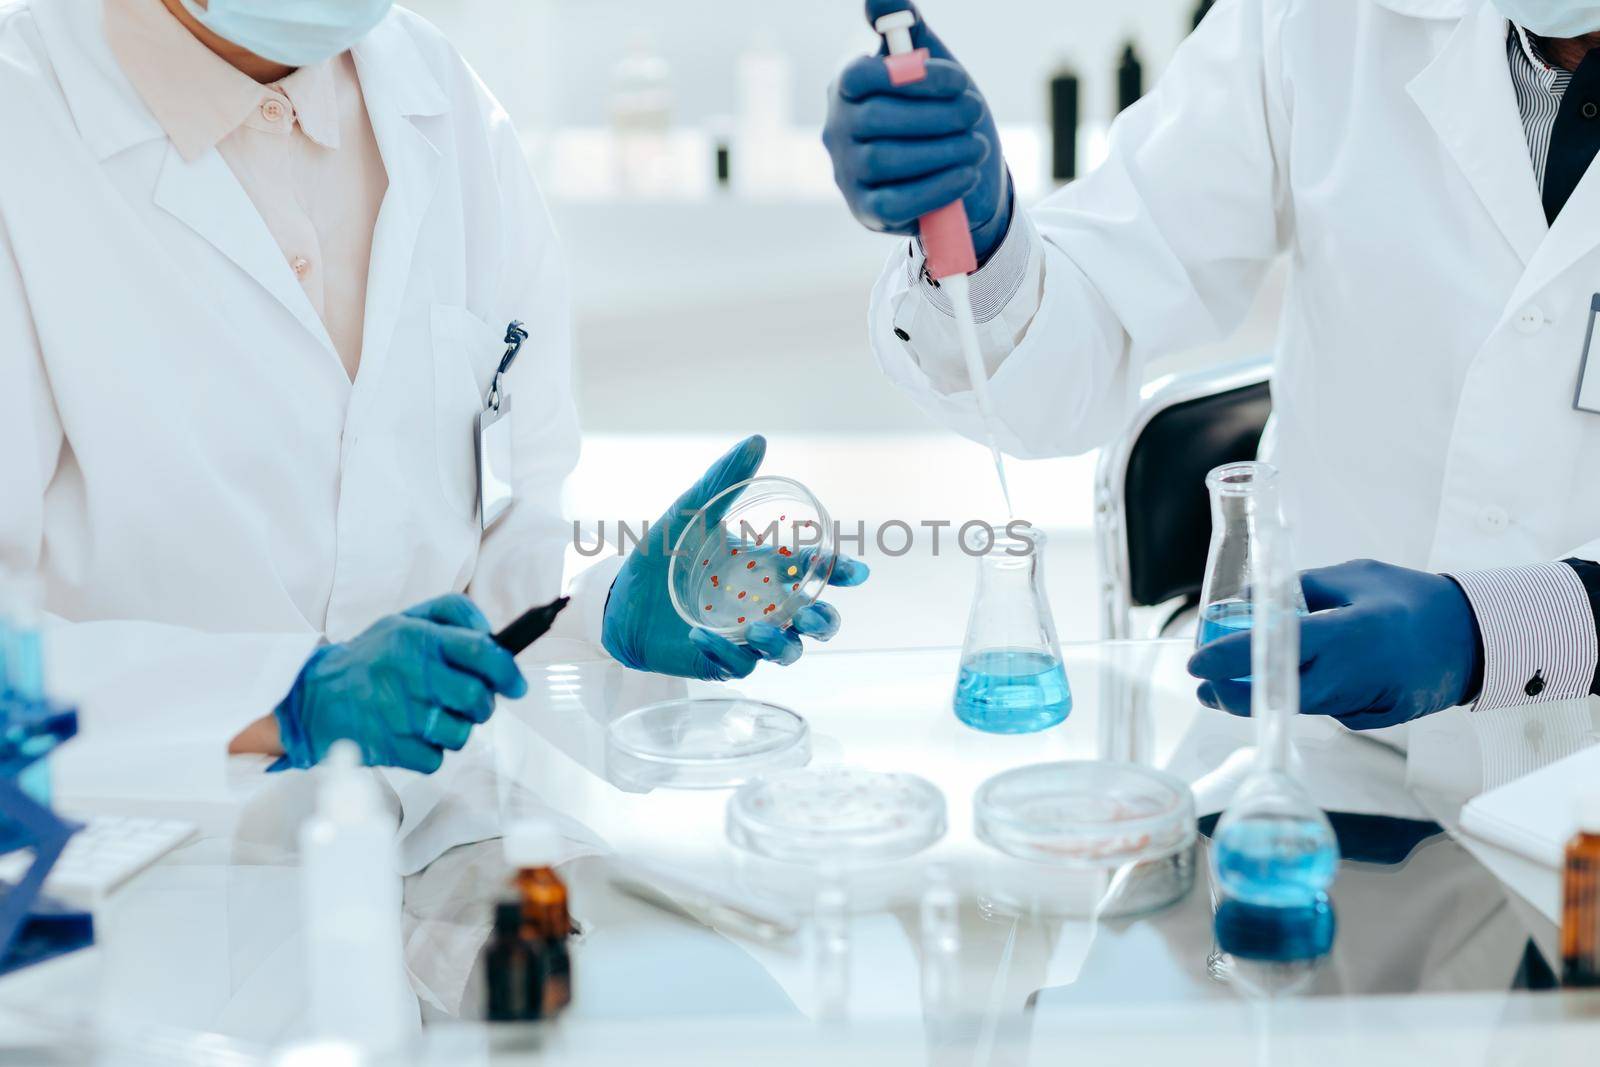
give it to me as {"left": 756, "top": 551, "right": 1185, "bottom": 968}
{"left": 822, "top": 0, "right": 1011, "bottom": 262}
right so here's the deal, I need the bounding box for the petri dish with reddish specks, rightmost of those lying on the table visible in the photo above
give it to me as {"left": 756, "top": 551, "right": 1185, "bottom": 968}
{"left": 973, "top": 760, "right": 1195, "bottom": 867}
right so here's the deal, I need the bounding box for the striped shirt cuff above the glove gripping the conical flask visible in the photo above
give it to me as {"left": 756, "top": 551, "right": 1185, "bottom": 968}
{"left": 1448, "top": 563, "right": 1600, "bottom": 712}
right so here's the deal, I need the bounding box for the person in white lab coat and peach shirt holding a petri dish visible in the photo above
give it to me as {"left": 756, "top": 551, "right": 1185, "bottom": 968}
{"left": 0, "top": 0, "right": 864, "bottom": 844}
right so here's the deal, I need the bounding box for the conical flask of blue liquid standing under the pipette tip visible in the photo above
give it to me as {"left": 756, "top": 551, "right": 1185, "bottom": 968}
{"left": 955, "top": 525, "right": 1072, "bottom": 734}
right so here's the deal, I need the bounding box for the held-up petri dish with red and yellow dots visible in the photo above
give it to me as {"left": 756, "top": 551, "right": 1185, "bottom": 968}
{"left": 667, "top": 477, "right": 838, "bottom": 641}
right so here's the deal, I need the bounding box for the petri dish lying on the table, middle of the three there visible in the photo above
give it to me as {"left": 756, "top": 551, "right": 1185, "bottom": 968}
{"left": 728, "top": 766, "right": 946, "bottom": 865}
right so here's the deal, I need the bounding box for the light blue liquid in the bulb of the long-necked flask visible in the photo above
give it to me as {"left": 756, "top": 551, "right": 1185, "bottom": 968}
{"left": 1211, "top": 816, "right": 1339, "bottom": 907}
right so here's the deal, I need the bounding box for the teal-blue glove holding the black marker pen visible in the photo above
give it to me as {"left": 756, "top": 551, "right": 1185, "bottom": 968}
{"left": 272, "top": 593, "right": 528, "bottom": 774}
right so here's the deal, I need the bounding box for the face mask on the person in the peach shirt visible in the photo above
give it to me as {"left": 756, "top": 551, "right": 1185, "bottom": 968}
{"left": 182, "top": 0, "right": 394, "bottom": 67}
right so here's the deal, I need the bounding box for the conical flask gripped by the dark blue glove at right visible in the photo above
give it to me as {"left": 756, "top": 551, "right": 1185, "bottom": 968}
{"left": 1195, "top": 462, "right": 1306, "bottom": 646}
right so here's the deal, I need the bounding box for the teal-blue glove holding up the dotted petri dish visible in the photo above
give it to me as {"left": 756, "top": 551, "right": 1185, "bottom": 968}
{"left": 600, "top": 437, "right": 867, "bottom": 681}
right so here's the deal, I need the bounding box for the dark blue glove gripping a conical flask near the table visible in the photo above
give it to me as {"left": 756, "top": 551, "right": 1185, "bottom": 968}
{"left": 1189, "top": 560, "right": 1483, "bottom": 729}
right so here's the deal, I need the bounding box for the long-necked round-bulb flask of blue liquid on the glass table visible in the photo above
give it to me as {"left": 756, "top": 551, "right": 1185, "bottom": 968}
{"left": 1211, "top": 510, "right": 1339, "bottom": 990}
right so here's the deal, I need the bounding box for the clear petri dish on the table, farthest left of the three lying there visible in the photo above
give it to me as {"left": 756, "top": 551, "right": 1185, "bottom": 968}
{"left": 606, "top": 697, "right": 811, "bottom": 789}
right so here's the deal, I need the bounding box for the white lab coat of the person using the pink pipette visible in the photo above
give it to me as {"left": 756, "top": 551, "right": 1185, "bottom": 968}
{"left": 870, "top": 0, "right": 1600, "bottom": 793}
